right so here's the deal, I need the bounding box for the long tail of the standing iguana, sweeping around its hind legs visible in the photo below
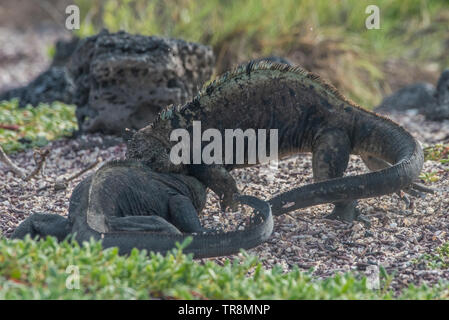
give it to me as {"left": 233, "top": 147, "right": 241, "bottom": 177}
{"left": 269, "top": 112, "right": 424, "bottom": 215}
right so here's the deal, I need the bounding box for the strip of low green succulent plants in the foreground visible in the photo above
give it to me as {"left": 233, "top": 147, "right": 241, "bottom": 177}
{"left": 0, "top": 238, "right": 448, "bottom": 299}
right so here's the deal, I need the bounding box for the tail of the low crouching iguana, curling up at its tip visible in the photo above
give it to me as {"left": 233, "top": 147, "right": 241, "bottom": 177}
{"left": 76, "top": 195, "right": 273, "bottom": 258}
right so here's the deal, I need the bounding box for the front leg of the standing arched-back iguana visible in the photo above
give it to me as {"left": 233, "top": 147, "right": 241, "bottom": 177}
{"left": 189, "top": 164, "right": 239, "bottom": 210}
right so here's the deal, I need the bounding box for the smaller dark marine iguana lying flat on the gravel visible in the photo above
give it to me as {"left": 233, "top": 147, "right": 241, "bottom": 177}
{"left": 12, "top": 160, "right": 273, "bottom": 258}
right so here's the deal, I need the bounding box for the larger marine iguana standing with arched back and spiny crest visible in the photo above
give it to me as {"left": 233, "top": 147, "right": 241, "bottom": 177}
{"left": 127, "top": 62, "right": 430, "bottom": 221}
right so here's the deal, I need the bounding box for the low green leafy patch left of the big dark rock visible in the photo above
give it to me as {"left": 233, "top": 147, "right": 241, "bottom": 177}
{"left": 0, "top": 100, "right": 77, "bottom": 153}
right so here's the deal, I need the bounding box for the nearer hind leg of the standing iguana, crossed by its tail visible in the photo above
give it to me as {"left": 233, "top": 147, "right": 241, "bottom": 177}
{"left": 312, "top": 128, "right": 360, "bottom": 222}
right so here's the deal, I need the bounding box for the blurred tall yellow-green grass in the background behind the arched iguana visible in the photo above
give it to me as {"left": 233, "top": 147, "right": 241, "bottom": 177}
{"left": 75, "top": 0, "right": 449, "bottom": 108}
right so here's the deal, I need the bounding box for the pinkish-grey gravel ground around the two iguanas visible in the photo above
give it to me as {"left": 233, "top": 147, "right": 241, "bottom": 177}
{"left": 0, "top": 110, "right": 449, "bottom": 289}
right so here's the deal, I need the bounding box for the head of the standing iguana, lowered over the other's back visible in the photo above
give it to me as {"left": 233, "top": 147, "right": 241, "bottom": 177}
{"left": 126, "top": 126, "right": 184, "bottom": 173}
